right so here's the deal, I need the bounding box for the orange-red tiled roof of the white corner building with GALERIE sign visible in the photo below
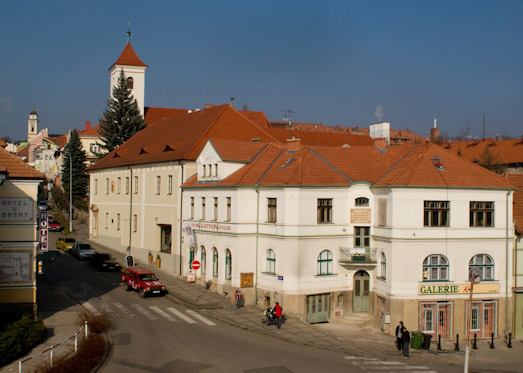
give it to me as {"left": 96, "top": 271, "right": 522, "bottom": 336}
{"left": 184, "top": 140, "right": 515, "bottom": 189}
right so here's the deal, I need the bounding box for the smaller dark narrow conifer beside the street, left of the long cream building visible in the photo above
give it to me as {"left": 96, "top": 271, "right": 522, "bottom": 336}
{"left": 62, "top": 130, "right": 89, "bottom": 198}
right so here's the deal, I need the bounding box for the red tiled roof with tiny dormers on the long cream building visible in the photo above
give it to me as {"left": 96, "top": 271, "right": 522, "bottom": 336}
{"left": 89, "top": 105, "right": 277, "bottom": 170}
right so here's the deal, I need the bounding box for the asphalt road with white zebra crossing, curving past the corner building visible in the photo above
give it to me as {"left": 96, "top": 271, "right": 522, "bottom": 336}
{"left": 45, "top": 233, "right": 442, "bottom": 373}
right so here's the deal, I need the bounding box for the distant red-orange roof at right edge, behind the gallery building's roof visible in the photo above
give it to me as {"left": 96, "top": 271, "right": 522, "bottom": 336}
{"left": 441, "top": 139, "right": 523, "bottom": 165}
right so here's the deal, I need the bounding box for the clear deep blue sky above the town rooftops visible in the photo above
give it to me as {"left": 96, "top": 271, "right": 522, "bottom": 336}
{"left": 0, "top": 0, "right": 523, "bottom": 140}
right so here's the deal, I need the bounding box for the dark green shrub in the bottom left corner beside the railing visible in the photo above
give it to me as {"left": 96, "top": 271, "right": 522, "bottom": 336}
{"left": 0, "top": 316, "right": 45, "bottom": 366}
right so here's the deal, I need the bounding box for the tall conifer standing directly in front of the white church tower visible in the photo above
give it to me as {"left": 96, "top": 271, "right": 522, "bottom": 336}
{"left": 98, "top": 69, "right": 145, "bottom": 156}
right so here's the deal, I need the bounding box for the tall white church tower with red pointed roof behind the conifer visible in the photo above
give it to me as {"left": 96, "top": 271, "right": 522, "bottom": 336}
{"left": 109, "top": 32, "right": 148, "bottom": 117}
